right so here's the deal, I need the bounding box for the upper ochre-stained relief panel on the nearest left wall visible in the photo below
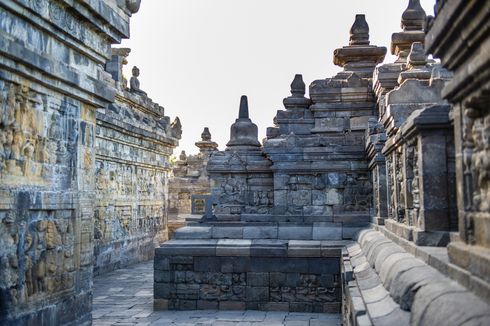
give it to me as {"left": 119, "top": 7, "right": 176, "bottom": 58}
{"left": 0, "top": 81, "right": 79, "bottom": 186}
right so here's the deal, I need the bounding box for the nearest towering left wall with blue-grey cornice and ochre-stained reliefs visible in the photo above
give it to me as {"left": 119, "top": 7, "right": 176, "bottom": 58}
{"left": 0, "top": 0, "right": 139, "bottom": 325}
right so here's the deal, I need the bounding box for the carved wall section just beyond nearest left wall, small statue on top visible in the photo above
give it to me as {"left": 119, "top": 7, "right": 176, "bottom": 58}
{"left": 94, "top": 48, "right": 182, "bottom": 275}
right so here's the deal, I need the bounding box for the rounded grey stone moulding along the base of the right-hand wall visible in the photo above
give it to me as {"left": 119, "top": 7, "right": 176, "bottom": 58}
{"left": 343, "top": 230, "right": 489, "bottom": 325}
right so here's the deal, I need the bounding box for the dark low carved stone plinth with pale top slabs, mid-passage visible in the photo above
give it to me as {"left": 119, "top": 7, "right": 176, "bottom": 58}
{"left": 154, "top": 239, "right": 343, "bottom": 313}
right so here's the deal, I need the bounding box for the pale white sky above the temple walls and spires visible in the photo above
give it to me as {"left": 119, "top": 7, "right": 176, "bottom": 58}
{"left": 122, "top": 0, "right": 435, "bottom": 156}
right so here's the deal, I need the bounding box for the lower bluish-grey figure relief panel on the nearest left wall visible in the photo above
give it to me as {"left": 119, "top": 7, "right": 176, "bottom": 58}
{"left": 0, "top": 210, "right": 78, "bottom": 304}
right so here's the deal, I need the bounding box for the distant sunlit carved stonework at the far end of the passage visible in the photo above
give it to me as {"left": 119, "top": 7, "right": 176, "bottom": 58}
{"left": 168, "top": 127, "right": 218, "bottom": 237}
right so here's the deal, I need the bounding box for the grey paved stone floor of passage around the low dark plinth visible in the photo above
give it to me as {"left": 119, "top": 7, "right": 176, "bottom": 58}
{"left": 92, "top": 262, "right": 341, "bottom": 326}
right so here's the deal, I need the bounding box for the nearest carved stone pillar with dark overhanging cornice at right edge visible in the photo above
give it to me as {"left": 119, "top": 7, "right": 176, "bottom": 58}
{"left": 426, "top": 1, "right": 490, "bottom": 302}
